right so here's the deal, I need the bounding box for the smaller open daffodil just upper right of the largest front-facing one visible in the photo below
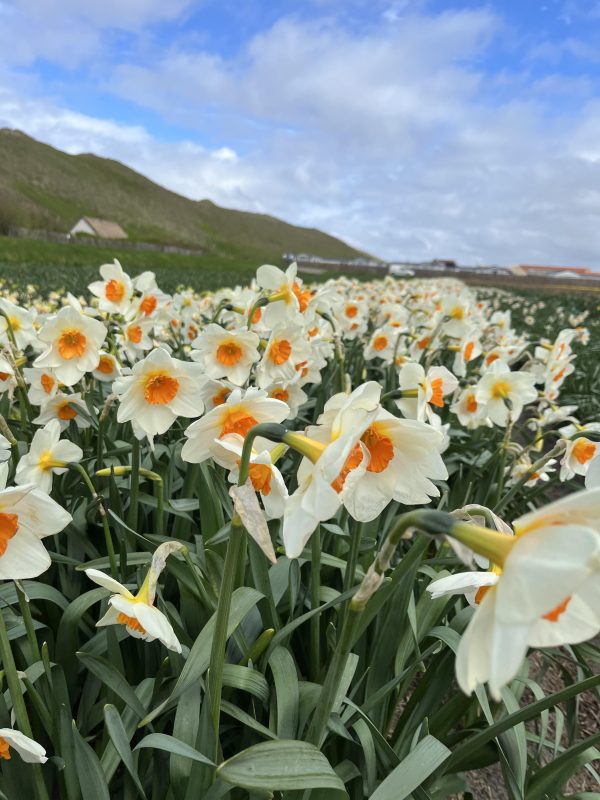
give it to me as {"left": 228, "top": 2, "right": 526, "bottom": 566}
{"left": 192, "top": 324, "right": 260, "bottom": 386}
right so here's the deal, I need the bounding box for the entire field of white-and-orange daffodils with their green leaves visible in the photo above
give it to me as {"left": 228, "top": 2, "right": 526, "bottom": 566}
{"left": 0, "top": 261, "right": 600, "bottom": 800}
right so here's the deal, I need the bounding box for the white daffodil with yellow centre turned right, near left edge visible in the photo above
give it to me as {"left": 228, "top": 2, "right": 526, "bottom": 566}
{"left": 15, "top": 419, "right": 83, "bottom": 494}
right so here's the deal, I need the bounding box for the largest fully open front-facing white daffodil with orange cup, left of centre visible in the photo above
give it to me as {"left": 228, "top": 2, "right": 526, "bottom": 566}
{"left": 113, "top": 347, "right": 204, "bottom": 437}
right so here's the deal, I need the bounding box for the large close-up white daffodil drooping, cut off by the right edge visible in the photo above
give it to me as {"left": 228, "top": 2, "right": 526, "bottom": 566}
{"left": 430, "top": 489, "right": 600, "bottom": 699}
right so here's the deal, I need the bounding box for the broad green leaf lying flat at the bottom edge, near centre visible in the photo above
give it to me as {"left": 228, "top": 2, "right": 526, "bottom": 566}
{"left": 217, "top": 739, "right": 347, "bottom": 797}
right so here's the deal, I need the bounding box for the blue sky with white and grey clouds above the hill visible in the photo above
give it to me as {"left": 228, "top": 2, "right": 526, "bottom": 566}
{"left": 0, "top": 0, "right": 600, "bottom": 269}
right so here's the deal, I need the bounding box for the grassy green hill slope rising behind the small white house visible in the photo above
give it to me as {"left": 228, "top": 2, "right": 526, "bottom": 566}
{"left": 0, "top": 128, "right": 362, "bottom": 261}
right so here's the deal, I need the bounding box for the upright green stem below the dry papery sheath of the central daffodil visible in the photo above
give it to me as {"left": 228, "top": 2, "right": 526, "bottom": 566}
{"left": 207, "top": 515, "right": 245, "bottom": 757}
